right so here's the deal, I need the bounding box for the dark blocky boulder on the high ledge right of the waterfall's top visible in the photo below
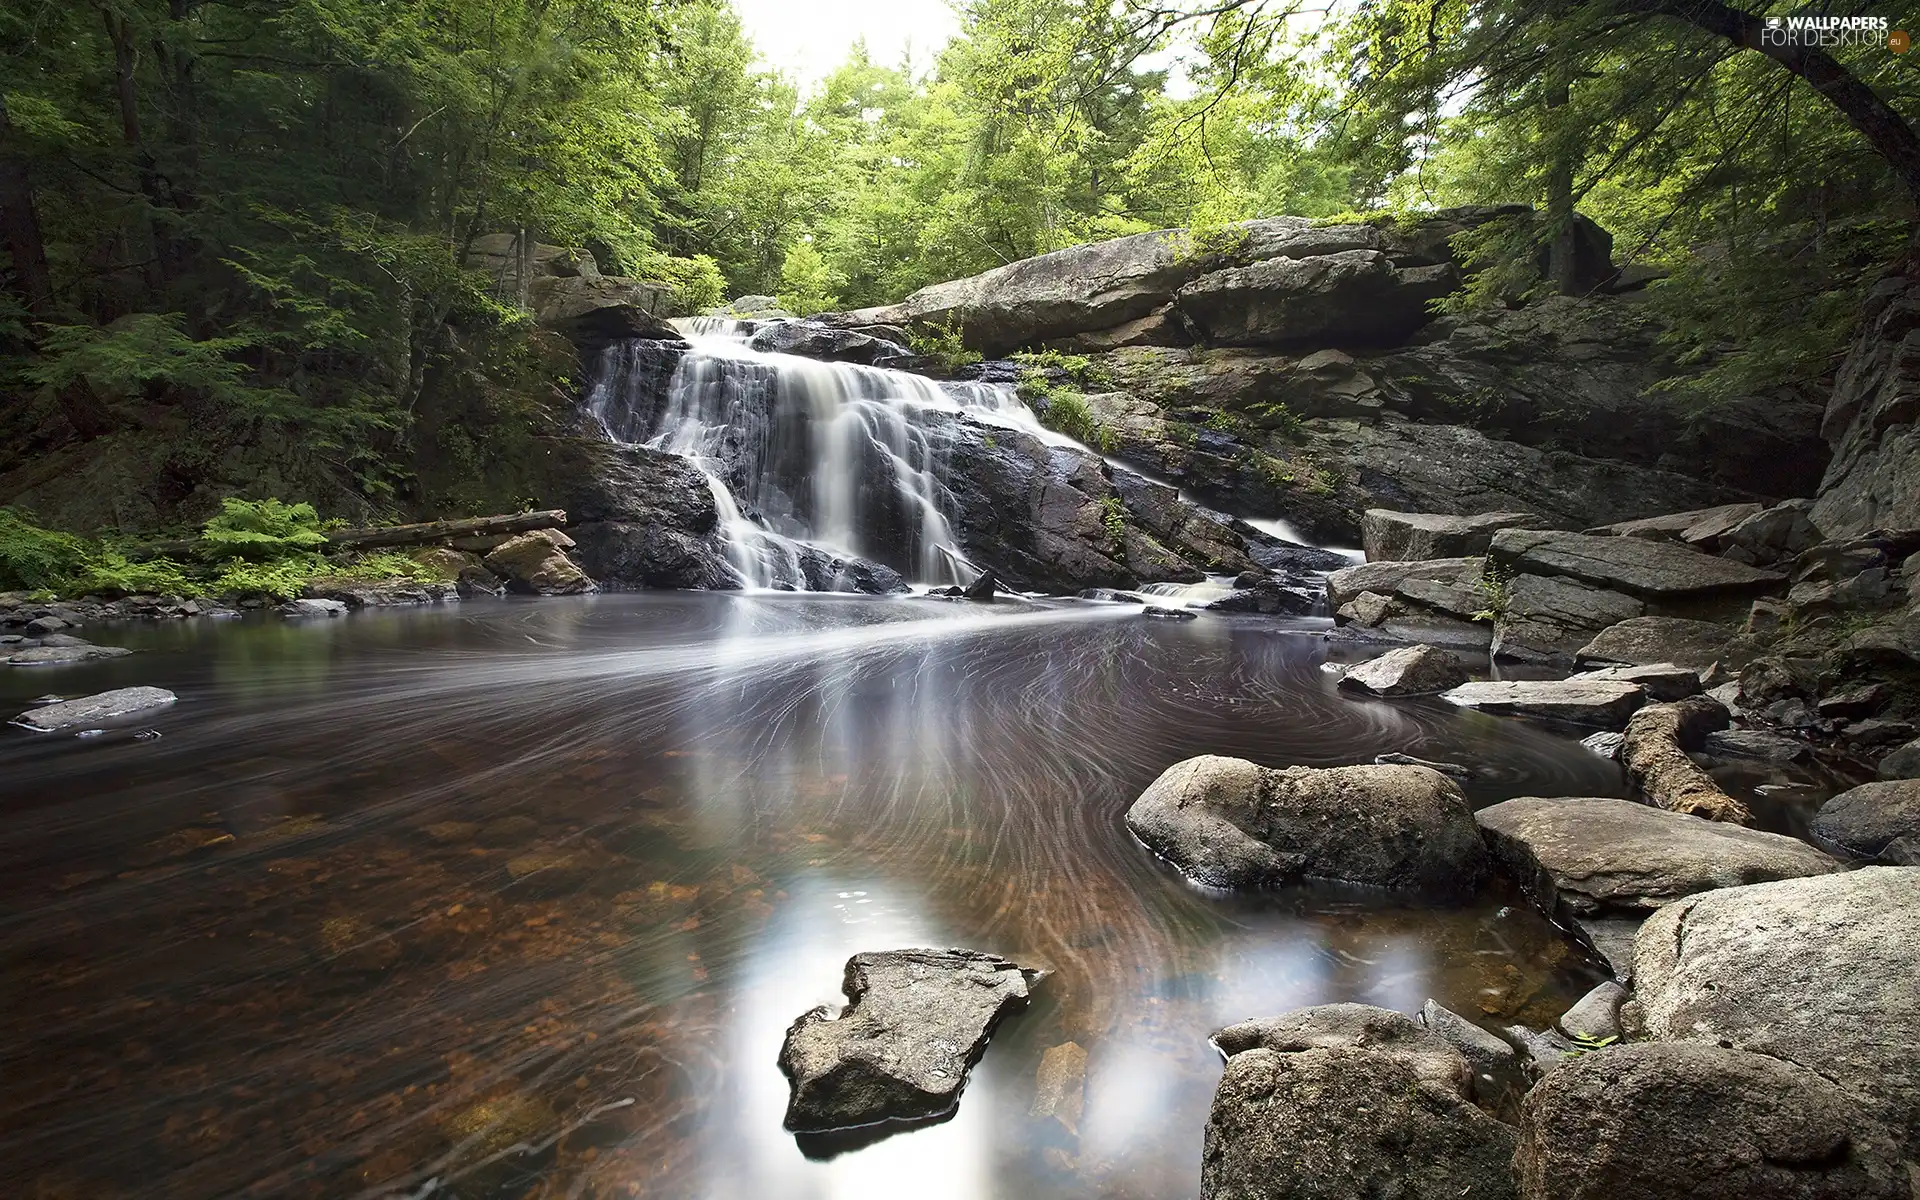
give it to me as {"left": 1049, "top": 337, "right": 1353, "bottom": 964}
{"left": 1173, "top": 250, "right": 1459, "bottom": 346}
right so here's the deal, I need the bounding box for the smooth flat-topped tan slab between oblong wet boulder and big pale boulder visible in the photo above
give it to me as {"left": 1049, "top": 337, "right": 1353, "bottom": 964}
{"left": 1475, "top": 797, "right": 1839, "bottom": 916}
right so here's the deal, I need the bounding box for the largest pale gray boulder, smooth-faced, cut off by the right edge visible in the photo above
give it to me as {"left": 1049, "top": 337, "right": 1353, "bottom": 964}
{"left": 1628, "top": 866, "right": 1920, "bottom": 1158}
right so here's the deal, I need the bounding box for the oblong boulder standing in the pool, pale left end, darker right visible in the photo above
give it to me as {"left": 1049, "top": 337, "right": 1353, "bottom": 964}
{"left": 1127, "top": 755, "right": 1488, "bottom": 899}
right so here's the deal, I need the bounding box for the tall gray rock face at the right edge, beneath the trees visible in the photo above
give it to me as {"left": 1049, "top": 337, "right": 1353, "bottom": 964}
{"left": 1812, "top": 267, "right": 1920, "bottom": 538}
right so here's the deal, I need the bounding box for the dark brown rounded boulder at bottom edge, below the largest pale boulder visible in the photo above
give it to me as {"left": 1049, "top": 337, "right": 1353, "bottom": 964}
{"left": 1513, "top": 1044, "right": 1910, "bottom": 1200}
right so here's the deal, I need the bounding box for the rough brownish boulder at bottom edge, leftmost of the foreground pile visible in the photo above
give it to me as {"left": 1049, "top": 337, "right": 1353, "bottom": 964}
{"left": 1200, "top": 1004, "right": 1515, "bottom": 1200}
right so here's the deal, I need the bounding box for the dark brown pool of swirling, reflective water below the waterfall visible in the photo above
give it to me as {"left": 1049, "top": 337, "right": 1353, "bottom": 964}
{"left": 0, "top": 593, "right": 1704, "bottom": 1200}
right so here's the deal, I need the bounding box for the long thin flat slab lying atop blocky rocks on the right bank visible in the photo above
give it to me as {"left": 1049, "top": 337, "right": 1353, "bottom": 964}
{"left": 1488, "top": 530, "right": 1786, "bottom": 599}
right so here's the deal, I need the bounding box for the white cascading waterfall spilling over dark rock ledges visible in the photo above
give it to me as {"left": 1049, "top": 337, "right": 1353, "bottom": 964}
{"left": 588, "top": 317, "right": 1060, "bottom": 589}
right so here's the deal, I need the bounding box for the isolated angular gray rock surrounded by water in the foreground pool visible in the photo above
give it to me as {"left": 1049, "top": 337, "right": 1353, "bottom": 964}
{"left": 780, "top": 950, "right": 1039, "bottom": 1133}
